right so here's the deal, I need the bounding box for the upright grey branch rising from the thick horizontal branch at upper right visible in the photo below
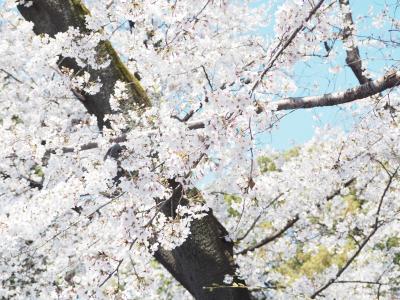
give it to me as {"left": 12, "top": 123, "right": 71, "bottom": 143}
{"left": 339, "top": 0, "right": 371, "bottom": 84}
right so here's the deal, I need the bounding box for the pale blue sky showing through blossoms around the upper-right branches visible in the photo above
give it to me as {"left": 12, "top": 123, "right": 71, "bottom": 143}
{"left": 259, "top": 0, "right": 400, "bottom": 150}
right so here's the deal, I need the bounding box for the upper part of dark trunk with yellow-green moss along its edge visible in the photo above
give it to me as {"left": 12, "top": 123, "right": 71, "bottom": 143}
{"left": 18, "top": 0, "right": 150, "bottom": 129}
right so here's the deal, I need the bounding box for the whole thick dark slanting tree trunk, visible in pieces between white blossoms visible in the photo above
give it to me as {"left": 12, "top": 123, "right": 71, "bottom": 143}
{"left": 18, "top": 0, "right": 250, "bottom": 300}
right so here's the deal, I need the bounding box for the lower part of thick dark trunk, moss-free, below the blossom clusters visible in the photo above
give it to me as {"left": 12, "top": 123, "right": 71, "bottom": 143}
{"left": 155, "top": 180, "right": 250, "bottom": 300}
